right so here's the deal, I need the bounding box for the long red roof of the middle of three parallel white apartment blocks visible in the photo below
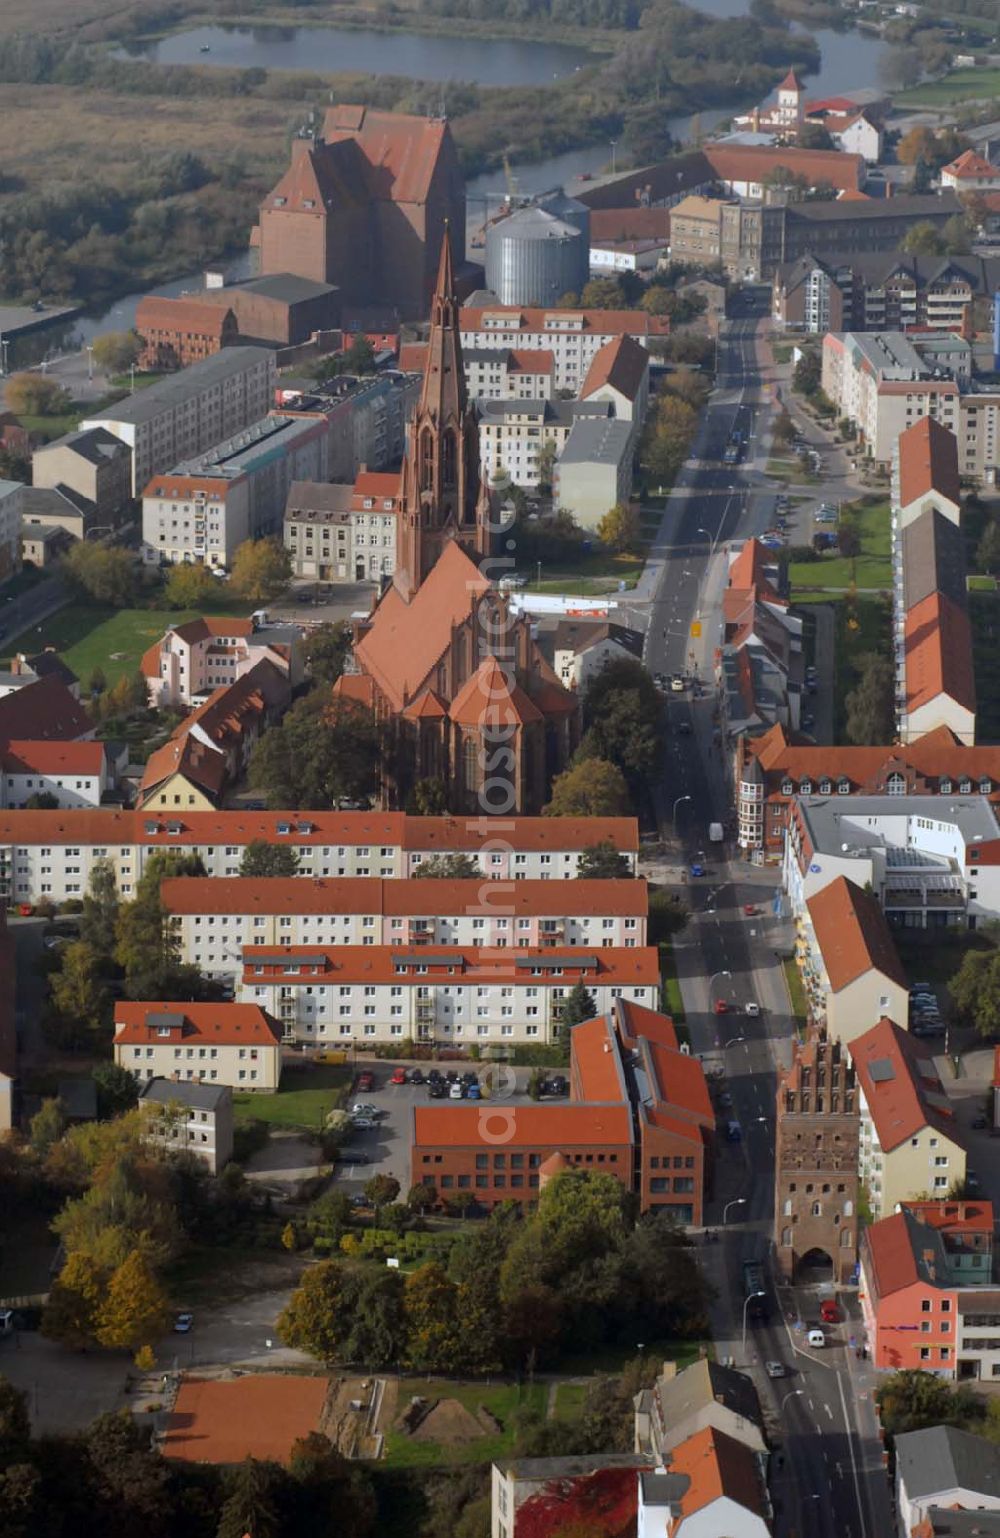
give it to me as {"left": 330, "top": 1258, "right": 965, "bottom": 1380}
{"left": 160, "top": 875, "right": 649, "bottom": 918}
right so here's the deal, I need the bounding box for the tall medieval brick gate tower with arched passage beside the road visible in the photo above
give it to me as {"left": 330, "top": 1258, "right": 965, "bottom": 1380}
{"left": 774, "top": 1035, "right": 858, "bottom": 1284}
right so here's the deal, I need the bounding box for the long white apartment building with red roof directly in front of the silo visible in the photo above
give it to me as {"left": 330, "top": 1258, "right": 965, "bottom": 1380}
{"left": 458, "top": 305, "right": 669, "bottom": 394}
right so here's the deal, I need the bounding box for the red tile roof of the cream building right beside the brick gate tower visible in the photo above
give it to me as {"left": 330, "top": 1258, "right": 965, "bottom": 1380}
{"left": 849, "top": 1017, "right": 955, "bottom": 1154}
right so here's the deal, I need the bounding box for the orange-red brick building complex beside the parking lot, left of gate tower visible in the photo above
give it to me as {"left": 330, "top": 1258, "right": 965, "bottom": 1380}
{"left": 411, "top": 998, "right": 715, "bottom": 1227}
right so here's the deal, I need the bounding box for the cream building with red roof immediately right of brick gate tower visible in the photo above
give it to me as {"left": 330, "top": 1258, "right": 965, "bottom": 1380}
{"left": 851, "top": 1018, "right": 966, "bottom": 1218}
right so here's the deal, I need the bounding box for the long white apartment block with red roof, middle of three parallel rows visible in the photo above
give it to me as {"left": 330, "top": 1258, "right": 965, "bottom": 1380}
{"left": 160, "top": 877, "right": 649, "bottom": 974}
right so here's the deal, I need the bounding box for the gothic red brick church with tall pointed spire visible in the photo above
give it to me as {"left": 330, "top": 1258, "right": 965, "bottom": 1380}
{"left": 334, "top": 231, "right": 580, "bottom": 814}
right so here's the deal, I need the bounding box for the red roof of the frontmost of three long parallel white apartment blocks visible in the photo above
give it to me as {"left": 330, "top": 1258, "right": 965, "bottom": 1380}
{"left": 243, "top": 943, "right": 660, "bottom": 987}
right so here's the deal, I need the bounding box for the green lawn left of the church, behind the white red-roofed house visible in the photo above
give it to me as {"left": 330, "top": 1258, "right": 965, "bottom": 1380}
{"left": 8, "top": 600, "right": 252, "bottom": 684}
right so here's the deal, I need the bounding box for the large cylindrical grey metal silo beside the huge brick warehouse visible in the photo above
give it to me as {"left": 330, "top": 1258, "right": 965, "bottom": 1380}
{"left": 486, "top": 208, "right": 591, "bottom": 305}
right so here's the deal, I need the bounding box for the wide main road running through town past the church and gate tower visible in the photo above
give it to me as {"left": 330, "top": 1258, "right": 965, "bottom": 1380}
{"left": 645, "top": 309, "right": 894, "bottom": 1538}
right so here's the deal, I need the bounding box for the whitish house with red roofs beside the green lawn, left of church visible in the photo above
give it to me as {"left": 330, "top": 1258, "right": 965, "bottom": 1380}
{"left": 140, "top": 615, "right": 302, "bottom": 709}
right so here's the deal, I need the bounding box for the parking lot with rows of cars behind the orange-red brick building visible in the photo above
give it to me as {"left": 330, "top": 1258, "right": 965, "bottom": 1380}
{"left": 335, "top": 1063, "right": 565, "bottom": 1195}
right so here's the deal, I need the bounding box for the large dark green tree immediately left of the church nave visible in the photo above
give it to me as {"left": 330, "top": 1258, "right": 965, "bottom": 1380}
{"left": 249, "top": 686, "right": 382, "bottom": 811}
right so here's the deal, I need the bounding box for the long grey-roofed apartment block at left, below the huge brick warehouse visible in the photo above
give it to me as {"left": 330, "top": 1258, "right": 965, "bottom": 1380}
{"left": 80, "top": 348, "right": 277, "bottom": 497}
